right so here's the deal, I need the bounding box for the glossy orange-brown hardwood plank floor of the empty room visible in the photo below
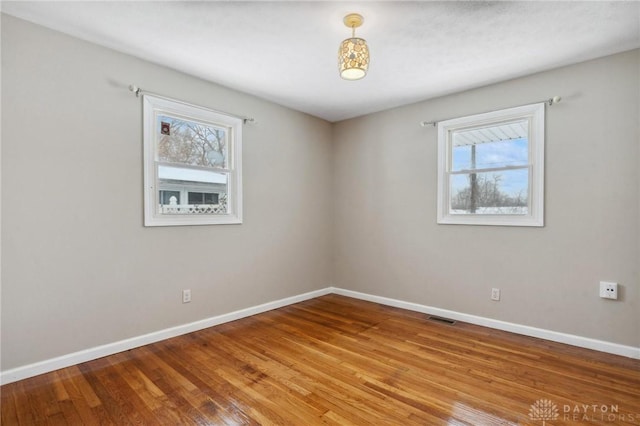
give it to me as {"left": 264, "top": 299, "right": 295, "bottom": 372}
{"left": 1, "top": 295, "right": 640, "bottom": 425}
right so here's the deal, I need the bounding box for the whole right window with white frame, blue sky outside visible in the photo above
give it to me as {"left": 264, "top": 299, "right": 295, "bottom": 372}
{"left": 438, "top": 103, "right": 544, "bottom": 226}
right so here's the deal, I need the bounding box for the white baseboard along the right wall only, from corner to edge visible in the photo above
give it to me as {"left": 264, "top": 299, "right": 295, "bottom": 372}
{"left": 330, "top": 287, "right": 640, "bottom": 359}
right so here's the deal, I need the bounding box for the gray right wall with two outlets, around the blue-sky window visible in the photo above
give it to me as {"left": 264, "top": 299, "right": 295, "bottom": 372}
{"left": 334, "top": 51, "right": 640, "bottom": 346}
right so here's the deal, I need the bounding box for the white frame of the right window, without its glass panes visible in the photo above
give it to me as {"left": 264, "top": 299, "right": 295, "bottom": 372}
{"left": 437, "top": 103, "right": 545, "bottom": 227}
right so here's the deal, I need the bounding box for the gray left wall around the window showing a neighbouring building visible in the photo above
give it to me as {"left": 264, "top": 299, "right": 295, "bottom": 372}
{"left": 1, "top": 15, "right": 332, "bottom": 370}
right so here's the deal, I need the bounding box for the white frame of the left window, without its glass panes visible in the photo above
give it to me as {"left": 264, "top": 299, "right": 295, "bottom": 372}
{"left": 142, "top": 94, "right": 244, "bottom": 226}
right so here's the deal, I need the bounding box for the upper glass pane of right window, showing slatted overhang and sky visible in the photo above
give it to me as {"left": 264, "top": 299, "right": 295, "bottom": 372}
{"left": 451, "top": 120, "right": 529, "bottom": 171}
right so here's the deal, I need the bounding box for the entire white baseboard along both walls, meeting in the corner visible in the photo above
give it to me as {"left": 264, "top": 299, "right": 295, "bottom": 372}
{"left": 0, "top": 287, "right": 640, "bottom": 385}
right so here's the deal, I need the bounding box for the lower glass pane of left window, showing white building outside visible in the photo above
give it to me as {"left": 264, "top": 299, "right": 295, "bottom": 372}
{"left": 158, "top": 165, "right": 228, "bottom": 214}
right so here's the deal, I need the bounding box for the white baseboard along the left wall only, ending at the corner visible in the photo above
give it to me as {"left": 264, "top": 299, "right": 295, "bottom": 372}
{"left": 0, "top": 288, "right": 331, "bottom": 385}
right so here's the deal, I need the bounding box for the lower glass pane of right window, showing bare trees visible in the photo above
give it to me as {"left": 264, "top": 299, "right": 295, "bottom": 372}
{"left": 450, "top": 168, "right": 529, "bottom": 215}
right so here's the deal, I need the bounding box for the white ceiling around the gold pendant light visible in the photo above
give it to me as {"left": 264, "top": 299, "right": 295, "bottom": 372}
{"left": 1, "top": 1, "right": 640, "bottom": 121}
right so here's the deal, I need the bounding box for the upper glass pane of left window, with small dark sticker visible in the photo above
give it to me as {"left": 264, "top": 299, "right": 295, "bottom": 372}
{"left": 156, "top": 115, "right": 228, "bottom": 169}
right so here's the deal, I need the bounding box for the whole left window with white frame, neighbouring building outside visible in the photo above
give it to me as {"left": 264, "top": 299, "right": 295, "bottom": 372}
{"left": 143, "top": 95, "right": 242, "bottom": 226}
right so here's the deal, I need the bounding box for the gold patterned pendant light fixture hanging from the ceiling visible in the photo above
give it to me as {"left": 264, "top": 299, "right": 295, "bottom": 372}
{"left": 338, "top": 13, "right": 369, "bottom": 80}
